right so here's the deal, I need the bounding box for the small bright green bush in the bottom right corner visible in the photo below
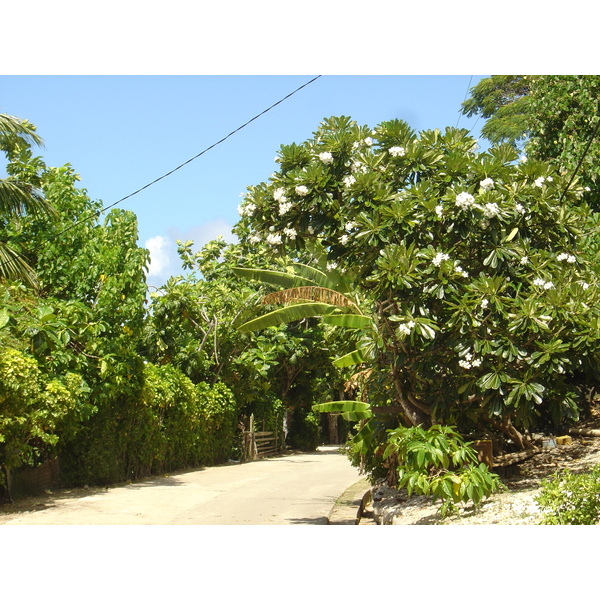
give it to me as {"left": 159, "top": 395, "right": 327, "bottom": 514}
{"left": 535, "top": 465, "right": 600, "bottom": 525}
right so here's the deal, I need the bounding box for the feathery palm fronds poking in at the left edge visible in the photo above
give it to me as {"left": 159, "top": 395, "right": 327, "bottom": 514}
{"left": 0, "top": 114, "right": 52, "bottom": 287}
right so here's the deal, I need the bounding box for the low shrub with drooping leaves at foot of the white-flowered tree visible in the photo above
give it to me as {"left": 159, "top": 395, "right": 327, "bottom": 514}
{"left": 383, "top": 425, "right": 502, "bottom": 516}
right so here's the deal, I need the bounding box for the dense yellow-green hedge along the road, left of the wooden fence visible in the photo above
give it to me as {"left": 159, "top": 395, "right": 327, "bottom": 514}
{"left": 60, "top": 364, "right": 236, "bottom": 485}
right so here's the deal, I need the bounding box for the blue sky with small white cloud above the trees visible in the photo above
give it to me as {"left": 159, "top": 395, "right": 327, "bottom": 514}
{"left": 0, "top": 75, "right": 490, "bottom": 285}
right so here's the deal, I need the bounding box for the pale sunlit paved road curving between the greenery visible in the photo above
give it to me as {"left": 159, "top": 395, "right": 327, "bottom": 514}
{"left": 0, "top": 446, "right": 360, "bottom": 525}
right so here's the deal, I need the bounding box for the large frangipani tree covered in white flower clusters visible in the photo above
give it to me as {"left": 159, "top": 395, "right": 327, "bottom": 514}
{"left": 236, "top": 117, "right": 600, "bottom": 447}
